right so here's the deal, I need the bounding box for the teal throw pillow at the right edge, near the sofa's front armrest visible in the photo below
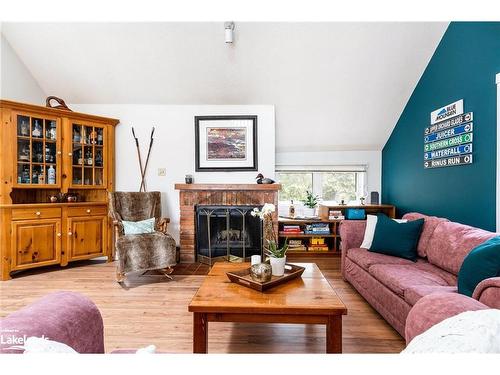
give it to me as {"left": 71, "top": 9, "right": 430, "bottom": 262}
{"left": 458, "top": 237, "right": 500, "bottom": 297}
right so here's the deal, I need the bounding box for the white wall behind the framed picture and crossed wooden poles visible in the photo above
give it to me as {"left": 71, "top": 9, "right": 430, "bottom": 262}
{"left": 69, "top": 104, "right": 275, "bottom": 240}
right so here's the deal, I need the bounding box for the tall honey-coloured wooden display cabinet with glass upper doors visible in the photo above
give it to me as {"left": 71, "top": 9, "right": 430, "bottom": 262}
{"left": 0, "top": 100, "right": 119, "bottom": 280}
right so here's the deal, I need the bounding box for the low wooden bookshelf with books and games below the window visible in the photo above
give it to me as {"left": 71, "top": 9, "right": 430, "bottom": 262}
{"left": 278, "top": 217, "right": 341, "bottom": 257}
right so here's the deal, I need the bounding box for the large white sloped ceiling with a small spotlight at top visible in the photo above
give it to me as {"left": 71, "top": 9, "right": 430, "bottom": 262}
{"left": 2, "top": 22, "right": 448, "bottom": 151}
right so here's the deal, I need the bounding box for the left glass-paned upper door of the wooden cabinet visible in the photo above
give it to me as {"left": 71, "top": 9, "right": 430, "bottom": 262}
{"left": 15, "top": 114, "right": 61, "bottom": 187}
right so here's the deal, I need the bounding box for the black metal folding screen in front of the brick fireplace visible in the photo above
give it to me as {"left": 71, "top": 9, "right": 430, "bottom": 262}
{"left": 196, "top": 205, "right": 262, "bottom": 265}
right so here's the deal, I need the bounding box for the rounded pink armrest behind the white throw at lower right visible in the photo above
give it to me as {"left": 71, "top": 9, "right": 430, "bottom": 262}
{"left": 405, "top": 293, "right": 488, "bottom": 345}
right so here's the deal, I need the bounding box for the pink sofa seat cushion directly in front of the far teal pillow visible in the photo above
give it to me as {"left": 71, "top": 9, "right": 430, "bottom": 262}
{"left": 368, "top": 264, "right": 448, "bottom": 297}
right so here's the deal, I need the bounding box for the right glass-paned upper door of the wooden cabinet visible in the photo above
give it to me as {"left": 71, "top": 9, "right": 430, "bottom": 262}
{"left": 71, "top": 123, "right": 106, "bottom": 187}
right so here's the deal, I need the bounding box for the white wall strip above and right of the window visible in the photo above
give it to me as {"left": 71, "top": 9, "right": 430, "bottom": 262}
{"left": 276, "top": 151, "right": 382, "bottom": 197}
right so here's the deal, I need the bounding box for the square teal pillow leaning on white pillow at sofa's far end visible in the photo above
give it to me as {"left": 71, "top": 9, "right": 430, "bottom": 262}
{"left": 369, "top": 214, "right": 424, "bottom": 262}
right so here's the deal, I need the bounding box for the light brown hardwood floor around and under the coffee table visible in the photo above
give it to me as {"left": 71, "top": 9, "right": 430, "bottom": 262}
{"left": 0, "top": 258, "right": 404, "bottom": 353}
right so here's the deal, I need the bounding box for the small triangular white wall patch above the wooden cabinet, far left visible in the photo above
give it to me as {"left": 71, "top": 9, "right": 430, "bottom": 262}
{"left": 0, "top": 35, "right": 47, "bottom": 105}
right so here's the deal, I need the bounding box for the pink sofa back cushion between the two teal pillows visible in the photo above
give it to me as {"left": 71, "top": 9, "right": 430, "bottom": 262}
{"left": 427, "top": 222, "right": 497, "bottom": 275}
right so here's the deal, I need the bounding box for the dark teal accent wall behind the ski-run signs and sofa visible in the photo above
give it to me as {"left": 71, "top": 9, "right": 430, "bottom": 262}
{"left": 382, "top": 22, "right": 500, "bottom": 231}
